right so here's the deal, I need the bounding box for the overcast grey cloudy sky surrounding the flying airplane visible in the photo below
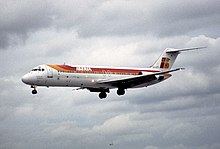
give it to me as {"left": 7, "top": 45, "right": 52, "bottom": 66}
{"left": 0, "top": 0, "right": 220, "bottom": 149}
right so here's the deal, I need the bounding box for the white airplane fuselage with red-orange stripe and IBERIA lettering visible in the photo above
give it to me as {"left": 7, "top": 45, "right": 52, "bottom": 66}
{"left": 22, "top": 65, "right": 168, "bottom": 89}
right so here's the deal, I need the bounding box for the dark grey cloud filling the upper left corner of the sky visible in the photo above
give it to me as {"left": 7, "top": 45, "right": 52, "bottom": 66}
{"left": 0, "top": 0, "right": 52, "bottom": 49}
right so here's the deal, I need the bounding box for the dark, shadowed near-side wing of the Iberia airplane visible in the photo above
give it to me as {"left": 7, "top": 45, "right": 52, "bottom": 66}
{"left": 98, "top": 68, "right": 184, "bottom": 89}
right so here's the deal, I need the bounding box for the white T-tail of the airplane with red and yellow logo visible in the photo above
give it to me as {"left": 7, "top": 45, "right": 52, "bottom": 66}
{"left": 151, "top": 47, "right": 206, "bottom": 71}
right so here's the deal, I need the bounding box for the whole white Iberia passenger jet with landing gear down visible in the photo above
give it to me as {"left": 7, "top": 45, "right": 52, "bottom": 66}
{"left": 21, "top": 47, "right": 206, "bottom": 99}
